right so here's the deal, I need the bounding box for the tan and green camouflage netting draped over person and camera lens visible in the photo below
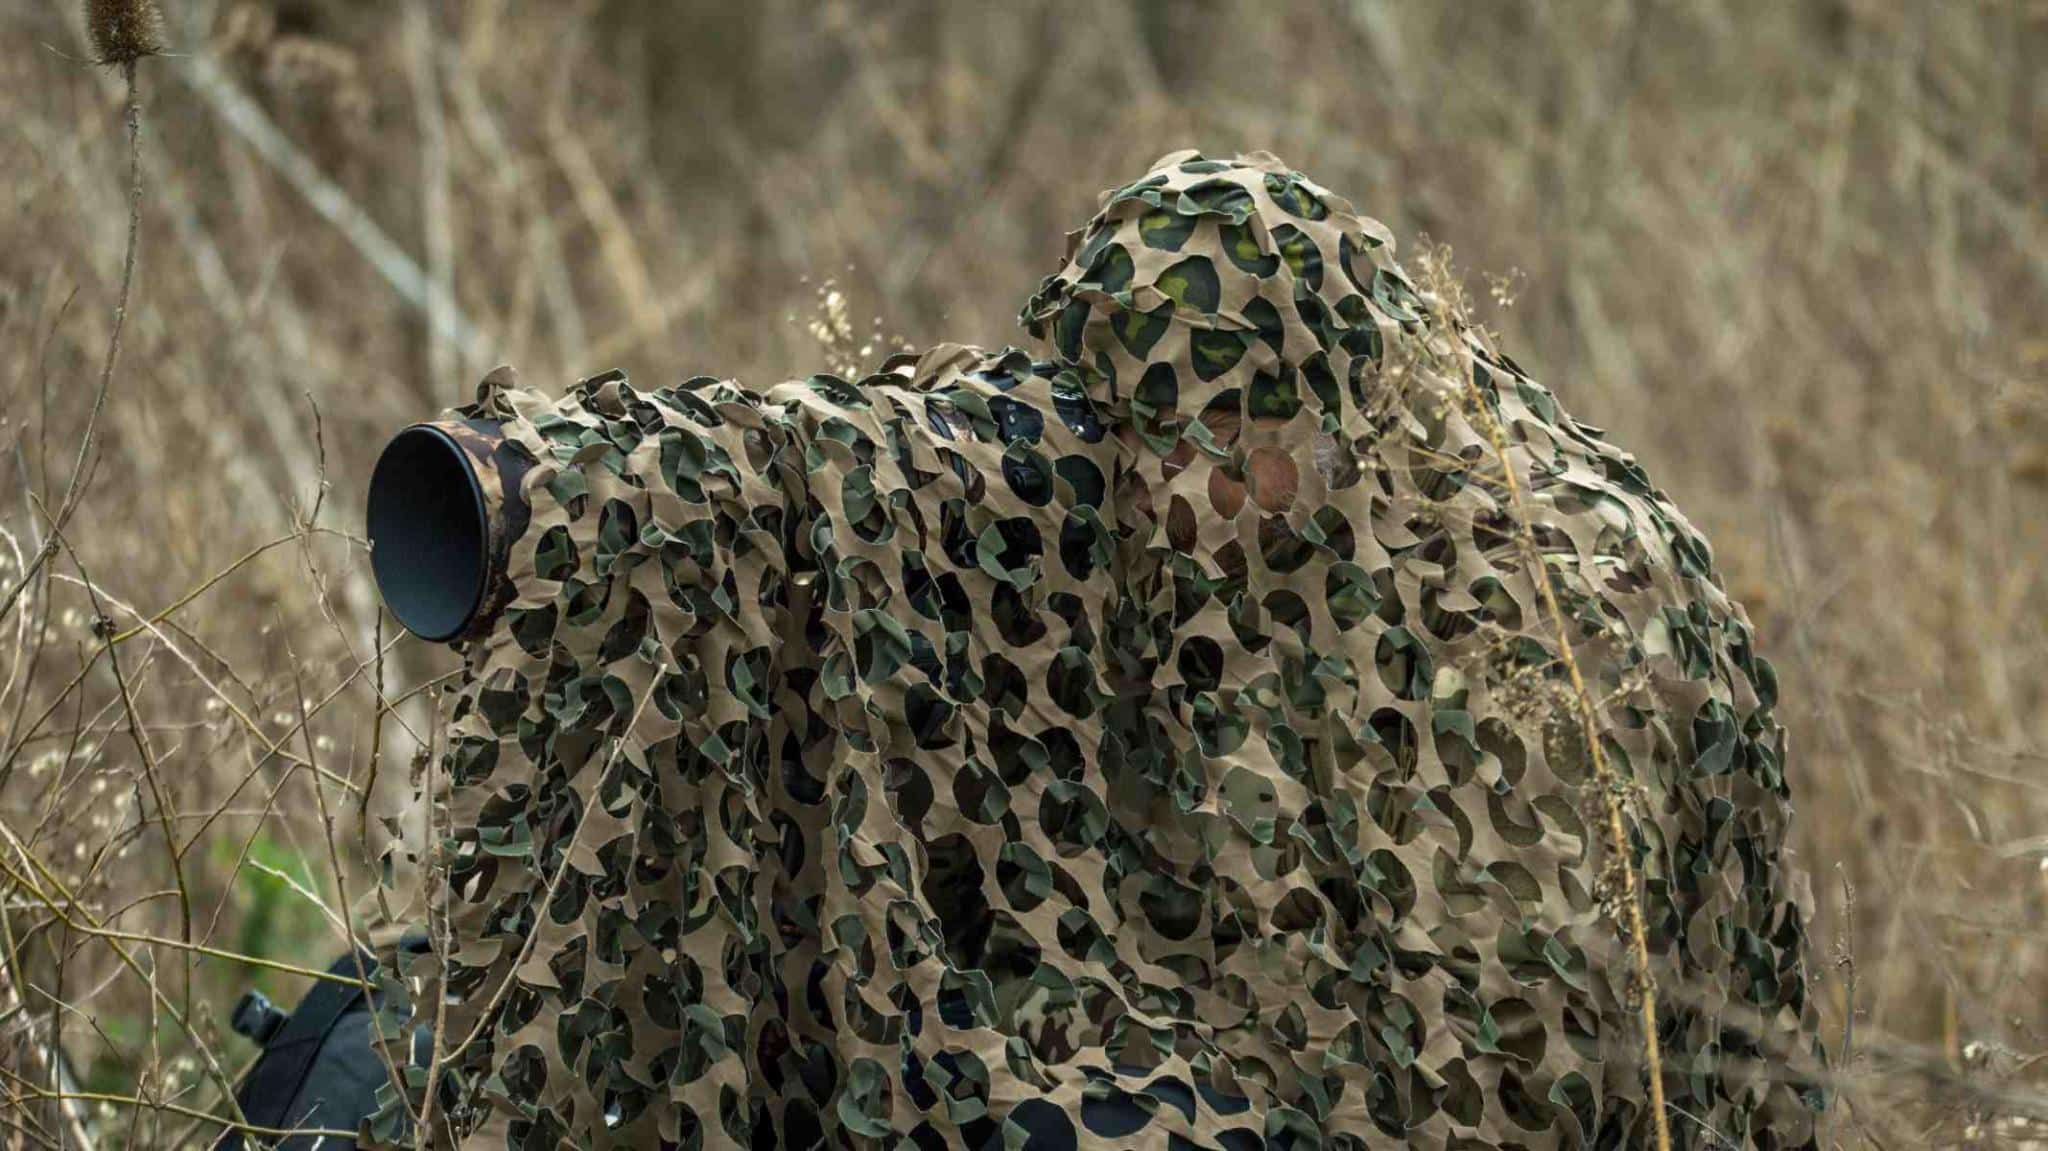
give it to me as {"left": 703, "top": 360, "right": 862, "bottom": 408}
{"left": 385, "top": 154, "right": 1823, "bottom": 1151}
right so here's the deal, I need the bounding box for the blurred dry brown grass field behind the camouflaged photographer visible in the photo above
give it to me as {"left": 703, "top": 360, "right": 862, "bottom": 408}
{"left": 0, "top": 0, "right": 2048, "bottom": 1149}
